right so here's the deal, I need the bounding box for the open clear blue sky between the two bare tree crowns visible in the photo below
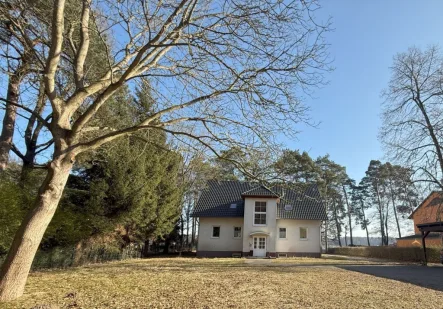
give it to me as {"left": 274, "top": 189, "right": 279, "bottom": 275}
{"left": 285, "top": 0, "right": 443, "bottom": 180}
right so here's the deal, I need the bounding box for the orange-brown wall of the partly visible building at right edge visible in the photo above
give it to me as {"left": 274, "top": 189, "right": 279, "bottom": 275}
{"left": 412, "top": 192, "right": 443, "bottom": 234}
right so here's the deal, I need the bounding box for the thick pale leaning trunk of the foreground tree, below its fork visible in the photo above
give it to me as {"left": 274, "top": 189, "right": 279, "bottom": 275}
{"left": 0, "top": 155, "right": 73, "bottom": 301}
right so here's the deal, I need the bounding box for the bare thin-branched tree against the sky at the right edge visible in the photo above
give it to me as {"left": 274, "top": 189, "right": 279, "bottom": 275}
{"left": 380, "top": 46, "right": 443, "bottom": 189}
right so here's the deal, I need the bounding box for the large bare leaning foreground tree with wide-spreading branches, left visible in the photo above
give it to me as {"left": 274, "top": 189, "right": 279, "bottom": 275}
{"left": 0, "top": 0, "right": 328, "bottom": 300}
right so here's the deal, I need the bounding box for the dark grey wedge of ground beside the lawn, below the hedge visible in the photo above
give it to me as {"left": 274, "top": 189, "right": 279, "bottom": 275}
{"left": 337, "top": 265, "right": 443, "bottom": 291}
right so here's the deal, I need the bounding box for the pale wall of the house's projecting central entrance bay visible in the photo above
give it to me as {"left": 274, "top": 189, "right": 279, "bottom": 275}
{"left": 243, "top": 197, "right": 277, "bottom": 254}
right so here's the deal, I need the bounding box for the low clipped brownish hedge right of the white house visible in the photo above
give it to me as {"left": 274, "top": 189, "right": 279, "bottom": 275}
{"left": 328, "top": 247, "right": 440, "bottom": 263}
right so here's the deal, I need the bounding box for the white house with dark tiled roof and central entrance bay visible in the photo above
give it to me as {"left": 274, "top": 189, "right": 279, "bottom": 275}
{"left": 193, "top": 181, "right": 326, "bottom": 257}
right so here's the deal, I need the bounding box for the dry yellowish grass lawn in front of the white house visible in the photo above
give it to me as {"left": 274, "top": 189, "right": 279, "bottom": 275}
{"left": 0, "top": 258, "right": 443, "bottom": 308}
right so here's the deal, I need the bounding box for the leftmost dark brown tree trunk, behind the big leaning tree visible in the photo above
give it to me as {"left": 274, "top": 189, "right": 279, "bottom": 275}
{"left": 0, "top": 74, "right": 20, "bottom": 171}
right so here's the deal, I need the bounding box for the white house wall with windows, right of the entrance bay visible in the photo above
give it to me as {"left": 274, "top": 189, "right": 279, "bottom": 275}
{"left": 275, "top": 219, "right": 321, "bottom": 253}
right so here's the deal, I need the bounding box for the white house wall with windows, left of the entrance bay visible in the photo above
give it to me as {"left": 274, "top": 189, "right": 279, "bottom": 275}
{"left": 197, "top": 217, "right": 245, "bottom": 252}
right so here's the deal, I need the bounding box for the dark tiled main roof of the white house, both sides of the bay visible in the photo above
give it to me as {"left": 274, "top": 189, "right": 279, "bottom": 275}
{"left": 193, "top": 181, "right": 327, "bottom": 220}
